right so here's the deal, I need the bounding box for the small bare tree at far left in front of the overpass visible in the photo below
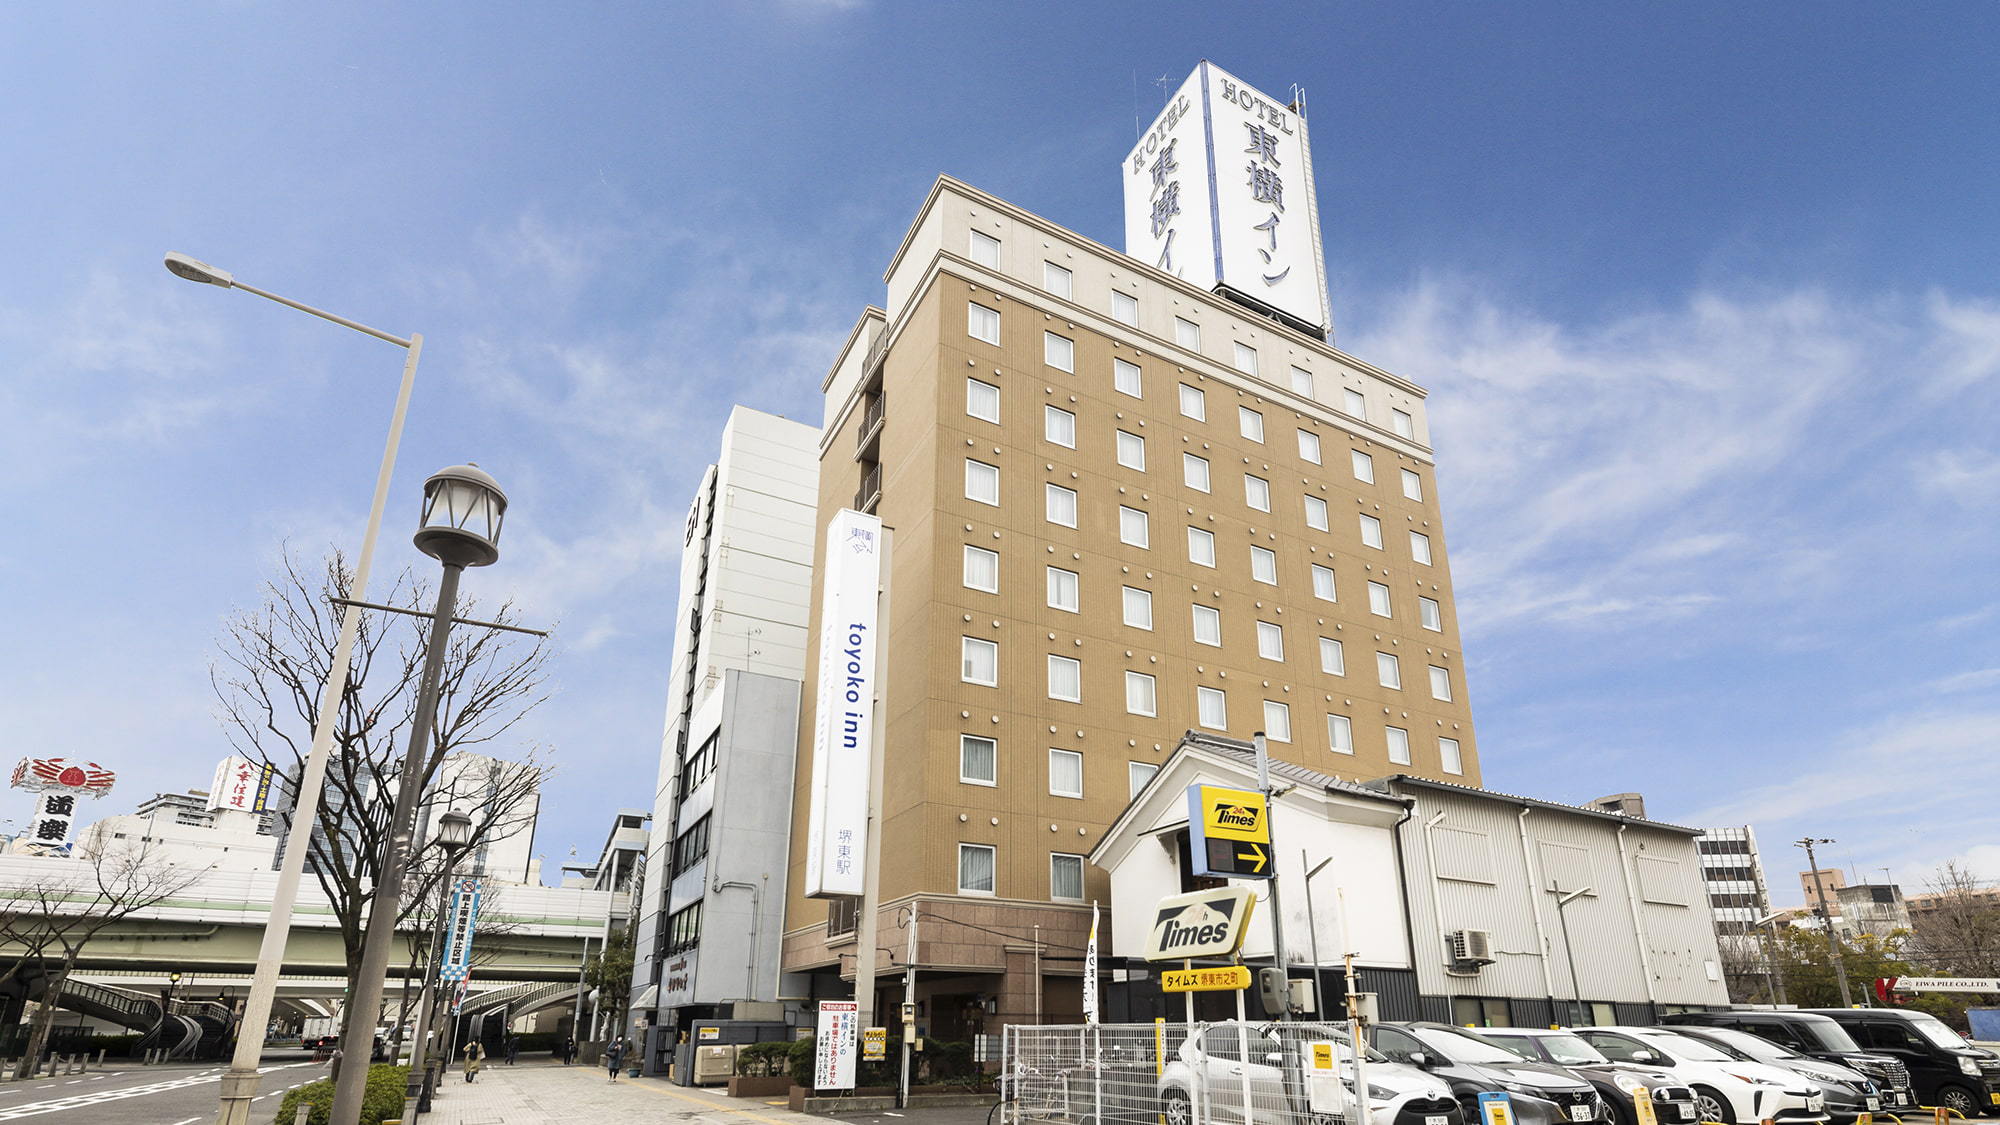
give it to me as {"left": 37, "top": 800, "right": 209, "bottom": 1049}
{"left": 0, "top": 833, "right": 204, "bottom": 1079}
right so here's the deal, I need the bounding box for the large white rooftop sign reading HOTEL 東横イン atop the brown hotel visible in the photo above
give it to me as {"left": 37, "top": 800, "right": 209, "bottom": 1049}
{"left": 1124, "top": 60, "right": 1330, "bottom": 330}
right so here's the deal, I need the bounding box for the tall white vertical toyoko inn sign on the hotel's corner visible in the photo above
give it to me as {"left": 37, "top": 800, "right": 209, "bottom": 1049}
{"left": 806, "top": 508, "right": 882, "bottom": 897}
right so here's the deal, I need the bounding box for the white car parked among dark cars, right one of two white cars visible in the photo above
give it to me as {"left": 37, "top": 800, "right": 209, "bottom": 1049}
{"left": 1570, "top": 1027, "right": 1826, "bottom": 1125}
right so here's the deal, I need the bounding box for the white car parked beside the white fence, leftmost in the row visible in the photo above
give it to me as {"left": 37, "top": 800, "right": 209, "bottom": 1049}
{"left": 1158, "top": 1021, "right": 1464, "bottom": 1125}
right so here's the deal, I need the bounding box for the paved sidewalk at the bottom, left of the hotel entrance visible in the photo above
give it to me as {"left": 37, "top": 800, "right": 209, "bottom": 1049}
{"left": 418, "top": 1061, "right": 828, "bottom": 1125}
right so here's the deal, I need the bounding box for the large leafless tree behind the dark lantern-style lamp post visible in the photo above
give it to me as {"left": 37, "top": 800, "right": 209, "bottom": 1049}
{"left": 210, "top": 550, "right": 550, "bottom": 1043}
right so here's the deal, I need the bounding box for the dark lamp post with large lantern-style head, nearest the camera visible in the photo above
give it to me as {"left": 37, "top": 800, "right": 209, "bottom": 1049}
{"left": 328, "top": 464, "right": 506, "bottom": 1125}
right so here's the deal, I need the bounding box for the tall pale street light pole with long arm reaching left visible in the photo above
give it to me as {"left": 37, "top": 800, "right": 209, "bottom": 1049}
{"left": 166, "top": 254, "right": 424, "bottom": 1125}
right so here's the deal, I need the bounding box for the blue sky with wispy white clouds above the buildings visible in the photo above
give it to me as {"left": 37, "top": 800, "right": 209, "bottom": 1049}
{"left": 0, "top": 0, "right": 2000, "bottom": 901}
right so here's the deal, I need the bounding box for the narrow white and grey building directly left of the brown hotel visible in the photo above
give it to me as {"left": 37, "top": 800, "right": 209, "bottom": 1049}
{"left": 632, "top": 406, "right": 820, "bottom": 1073}
